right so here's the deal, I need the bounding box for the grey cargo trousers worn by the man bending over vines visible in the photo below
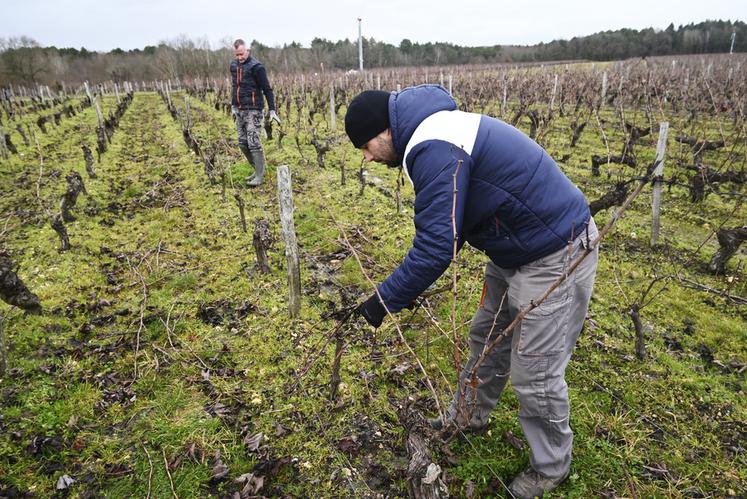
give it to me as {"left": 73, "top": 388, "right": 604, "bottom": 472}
{"left": 448, "top": 219, "right": 599, "bottom": 478}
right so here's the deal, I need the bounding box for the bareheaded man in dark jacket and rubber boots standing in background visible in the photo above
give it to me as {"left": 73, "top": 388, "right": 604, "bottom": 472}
{"left": 231, "top": 38, "right": 280, "bottom": 187}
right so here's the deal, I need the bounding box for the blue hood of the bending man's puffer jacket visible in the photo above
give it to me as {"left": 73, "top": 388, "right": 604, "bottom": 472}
{"left": 389, "top": 84, "right": 456, "bottom": 164}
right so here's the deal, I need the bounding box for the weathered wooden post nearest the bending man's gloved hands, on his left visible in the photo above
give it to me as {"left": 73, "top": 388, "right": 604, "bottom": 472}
{"left": 278, "top": 165, "right": 301, "bottom": 317}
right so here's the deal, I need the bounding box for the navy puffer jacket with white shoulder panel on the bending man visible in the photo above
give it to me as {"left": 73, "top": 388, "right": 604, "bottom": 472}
{"left": 379, "top": 85, "right": 591, "bottom": 312}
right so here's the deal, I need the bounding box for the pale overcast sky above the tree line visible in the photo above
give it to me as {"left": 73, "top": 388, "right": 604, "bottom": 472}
{"left": 0, "top": 0, "right": 747, "bottom": 51}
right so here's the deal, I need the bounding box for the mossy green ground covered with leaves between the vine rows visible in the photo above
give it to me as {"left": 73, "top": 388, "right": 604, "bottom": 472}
{"left": 0, "top": 84, "right": 747, "bottom": 497}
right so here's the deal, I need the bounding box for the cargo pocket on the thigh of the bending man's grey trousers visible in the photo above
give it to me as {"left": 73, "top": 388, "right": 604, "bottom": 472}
{"left": 516, "top": 292, "right": 572, "bottom": 356}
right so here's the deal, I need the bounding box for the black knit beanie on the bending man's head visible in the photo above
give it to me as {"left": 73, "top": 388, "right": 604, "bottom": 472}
{"left": 345, "top": 90, "right": 391, "bottom": 148}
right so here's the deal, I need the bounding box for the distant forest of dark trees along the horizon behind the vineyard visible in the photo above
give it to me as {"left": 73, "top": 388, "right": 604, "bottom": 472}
{"left": 0, "top": 21, "right": 747, "bottom": 88}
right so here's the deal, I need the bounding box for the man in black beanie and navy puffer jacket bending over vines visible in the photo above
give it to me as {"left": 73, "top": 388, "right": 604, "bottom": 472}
{"left": 345, "top": 85, "right": 598, "bottom": 497}
